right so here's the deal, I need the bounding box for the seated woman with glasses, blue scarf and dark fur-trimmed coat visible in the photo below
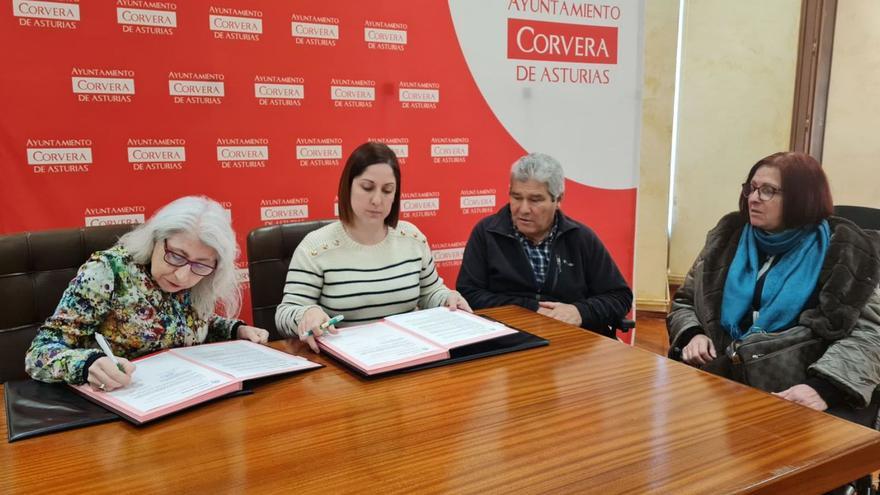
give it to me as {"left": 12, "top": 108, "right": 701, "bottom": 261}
{"left": 667, "top": 152, "right": 880, "bottom": 426}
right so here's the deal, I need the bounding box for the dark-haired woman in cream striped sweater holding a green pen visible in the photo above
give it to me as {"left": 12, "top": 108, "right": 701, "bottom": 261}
{"left": 275, "top": 142, "right": 471, "bottom": 352}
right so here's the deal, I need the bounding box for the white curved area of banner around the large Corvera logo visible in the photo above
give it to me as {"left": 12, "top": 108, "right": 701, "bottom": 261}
{"left": 449, "top": 0, "right": 644, "bottom": 189}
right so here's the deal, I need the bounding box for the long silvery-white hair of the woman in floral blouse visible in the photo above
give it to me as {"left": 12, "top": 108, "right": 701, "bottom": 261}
{"left": 117, "top": 196, "right": 241, "bottom": 319}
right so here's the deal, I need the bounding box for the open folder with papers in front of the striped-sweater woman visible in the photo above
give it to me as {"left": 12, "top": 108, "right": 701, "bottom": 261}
{"left": 317, "top": 307, "right": 548, "bottom": 377}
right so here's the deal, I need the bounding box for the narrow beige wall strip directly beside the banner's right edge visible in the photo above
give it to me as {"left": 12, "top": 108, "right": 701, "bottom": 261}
{"left": 635, "top": 0, "right": 679, "bottom": 311}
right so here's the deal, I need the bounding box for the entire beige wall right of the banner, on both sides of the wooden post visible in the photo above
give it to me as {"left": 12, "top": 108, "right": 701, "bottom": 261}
{"left": 635, "top": 0, "right": 880, "bottom": 309}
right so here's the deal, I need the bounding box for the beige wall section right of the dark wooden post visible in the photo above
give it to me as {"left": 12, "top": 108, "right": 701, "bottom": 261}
{"left": 822, "top": 0, "right": 880, "bottom": 208}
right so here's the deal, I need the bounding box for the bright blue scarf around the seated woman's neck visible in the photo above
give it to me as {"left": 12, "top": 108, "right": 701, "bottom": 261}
{"left": 721, "top": 220, "right": 831, "bottom": 339}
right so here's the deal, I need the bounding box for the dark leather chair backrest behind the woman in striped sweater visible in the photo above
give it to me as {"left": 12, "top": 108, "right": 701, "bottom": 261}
{"left": 248, "top": 220, "right": 335, "bottom": 340}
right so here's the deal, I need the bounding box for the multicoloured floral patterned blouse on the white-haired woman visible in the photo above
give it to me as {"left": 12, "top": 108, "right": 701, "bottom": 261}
{"left": 25, "top": 246, "right": 242, "bottom": 384}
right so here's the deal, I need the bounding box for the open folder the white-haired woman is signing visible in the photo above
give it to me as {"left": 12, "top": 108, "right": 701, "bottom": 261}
{"left": 73, "top": 340, "right": 321, "bottom": 424}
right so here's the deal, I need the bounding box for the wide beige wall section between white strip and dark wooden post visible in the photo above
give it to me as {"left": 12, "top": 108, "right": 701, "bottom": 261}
{"left": 668, "top": 0, "right": 801, "bottom": 280}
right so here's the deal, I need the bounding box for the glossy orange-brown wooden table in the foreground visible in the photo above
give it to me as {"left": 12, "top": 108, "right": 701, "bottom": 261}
{"left": 0, "top": 307, "right": 880, "bottom": 494}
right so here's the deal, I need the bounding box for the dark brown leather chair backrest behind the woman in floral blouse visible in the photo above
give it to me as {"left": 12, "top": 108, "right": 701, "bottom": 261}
{"left": 0, "top": 225, "right": 131, "bottom": 382}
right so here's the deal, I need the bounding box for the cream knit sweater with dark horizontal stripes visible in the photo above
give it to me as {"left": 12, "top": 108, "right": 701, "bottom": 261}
{"left": 275, "top": 221, "right": 451, "bottom": 337}
